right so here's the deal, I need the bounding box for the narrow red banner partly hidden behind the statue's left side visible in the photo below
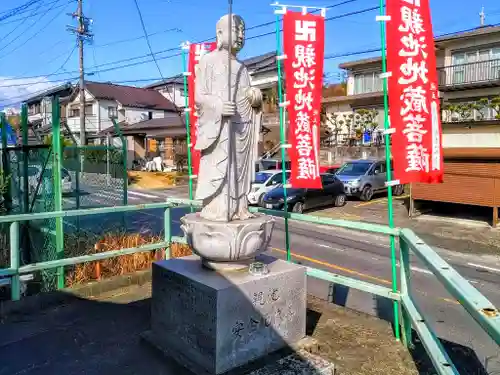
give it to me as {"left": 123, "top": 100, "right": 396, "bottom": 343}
{"left": 188, "top": 42, "right": 217, "bottom": 175}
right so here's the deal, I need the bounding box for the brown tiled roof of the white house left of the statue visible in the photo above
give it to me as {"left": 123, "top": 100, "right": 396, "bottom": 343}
{"left": 85, "top": 82, "right": 176, "bottom": 111}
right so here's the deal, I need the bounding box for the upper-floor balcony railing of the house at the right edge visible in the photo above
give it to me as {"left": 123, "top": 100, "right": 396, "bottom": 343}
{"left": 438, "top": 59, "right": 500, "bottom": 87}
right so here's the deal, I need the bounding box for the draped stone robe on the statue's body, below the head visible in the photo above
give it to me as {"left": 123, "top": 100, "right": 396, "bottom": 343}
{"left": 195, "top": 50, "right": 262, "bottom": 221}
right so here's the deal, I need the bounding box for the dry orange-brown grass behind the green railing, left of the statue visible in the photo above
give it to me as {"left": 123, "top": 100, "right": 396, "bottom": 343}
{"left": 66, "top": 233, "right": 192, "bottom": 286}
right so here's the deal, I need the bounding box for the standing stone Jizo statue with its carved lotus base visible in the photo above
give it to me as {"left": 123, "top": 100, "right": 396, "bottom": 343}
{"left": 181, "top": 15, "right": 274, "bottom": 271}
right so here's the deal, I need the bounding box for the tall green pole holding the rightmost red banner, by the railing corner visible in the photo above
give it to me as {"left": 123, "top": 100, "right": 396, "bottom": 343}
{"left": 379, "top": 0, "right": 400, "bottom": 341}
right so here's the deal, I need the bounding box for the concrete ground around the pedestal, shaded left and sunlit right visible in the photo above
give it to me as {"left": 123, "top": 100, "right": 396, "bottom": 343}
{"left": 0, "top": 283, "right": 431, "bottom": 375}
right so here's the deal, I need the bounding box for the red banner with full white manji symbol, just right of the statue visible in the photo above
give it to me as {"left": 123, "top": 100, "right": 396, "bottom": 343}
{"left": 283, "top": 12, "right": 325, "bottom": 189}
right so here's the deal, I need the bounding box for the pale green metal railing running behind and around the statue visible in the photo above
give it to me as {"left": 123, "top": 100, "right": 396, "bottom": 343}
{"left": 0, "top": 199, "right": 500, "bottom": 374}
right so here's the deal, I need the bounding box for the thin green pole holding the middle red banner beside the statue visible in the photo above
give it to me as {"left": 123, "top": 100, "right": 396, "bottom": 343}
{"left": 276, "top": 14, "right": 292, "bottom": 262}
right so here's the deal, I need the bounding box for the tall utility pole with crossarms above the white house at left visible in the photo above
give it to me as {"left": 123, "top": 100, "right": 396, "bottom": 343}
{"left": 68, "top": 0, "right": 93, "bottom": 146}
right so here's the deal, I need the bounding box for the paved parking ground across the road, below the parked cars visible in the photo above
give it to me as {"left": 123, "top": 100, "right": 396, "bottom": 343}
{"left": 314, "top": 195, "right": 500, "bottom": 255}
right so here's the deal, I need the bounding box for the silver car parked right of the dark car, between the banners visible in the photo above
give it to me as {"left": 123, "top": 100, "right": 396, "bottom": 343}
{"left": 335, "top": 159, "right": 404, "bottom": 201}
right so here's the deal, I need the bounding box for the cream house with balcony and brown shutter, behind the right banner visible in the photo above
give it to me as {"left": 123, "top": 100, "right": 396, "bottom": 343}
{"left": 323, "top": 26, "right": 500, "bottom": 225}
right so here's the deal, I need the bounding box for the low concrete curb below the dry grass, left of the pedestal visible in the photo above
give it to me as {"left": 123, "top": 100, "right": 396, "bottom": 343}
{"left": 0, "top": 270, "right": 151, "bottom": 321}
